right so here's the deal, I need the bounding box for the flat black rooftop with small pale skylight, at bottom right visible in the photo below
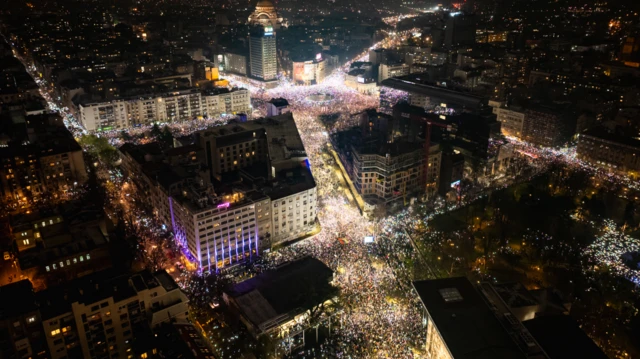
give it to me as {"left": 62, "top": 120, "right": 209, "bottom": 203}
{"left": 413, "top": 277, "right": 526, "bottom": 359}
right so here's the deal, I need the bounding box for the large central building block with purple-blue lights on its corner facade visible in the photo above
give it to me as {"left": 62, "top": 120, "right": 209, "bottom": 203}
{"left": 120, "top": 113, "right": 317, "bottom": 271}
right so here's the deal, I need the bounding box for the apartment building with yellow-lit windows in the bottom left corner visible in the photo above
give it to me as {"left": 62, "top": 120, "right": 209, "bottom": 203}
{"left": 36, "top": 271, "right": 188, "bottom": 359}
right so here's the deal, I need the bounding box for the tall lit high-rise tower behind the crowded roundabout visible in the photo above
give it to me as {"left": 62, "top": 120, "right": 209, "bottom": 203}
{"left": 249, "top": 26, "right": 278, "bottom": 82}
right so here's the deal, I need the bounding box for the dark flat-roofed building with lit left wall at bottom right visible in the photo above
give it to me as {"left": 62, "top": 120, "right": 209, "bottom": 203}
{"left": 413, "top": 277, "right": 607, "bottom": 359}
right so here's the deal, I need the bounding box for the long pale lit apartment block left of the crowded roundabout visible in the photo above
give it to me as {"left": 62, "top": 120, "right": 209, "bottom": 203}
{"left": 76, "top": 88, "right": 251, "bottom": 131}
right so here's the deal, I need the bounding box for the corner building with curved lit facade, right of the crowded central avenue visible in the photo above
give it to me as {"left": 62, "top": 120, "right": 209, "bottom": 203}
{"left": 331, "top": 111, "right": 441, "bottom": 207}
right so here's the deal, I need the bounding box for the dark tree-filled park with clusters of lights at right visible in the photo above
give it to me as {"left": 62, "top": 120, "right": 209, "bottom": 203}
{"left": 410, "top": 166, "right": 640, "bottom": 357}
